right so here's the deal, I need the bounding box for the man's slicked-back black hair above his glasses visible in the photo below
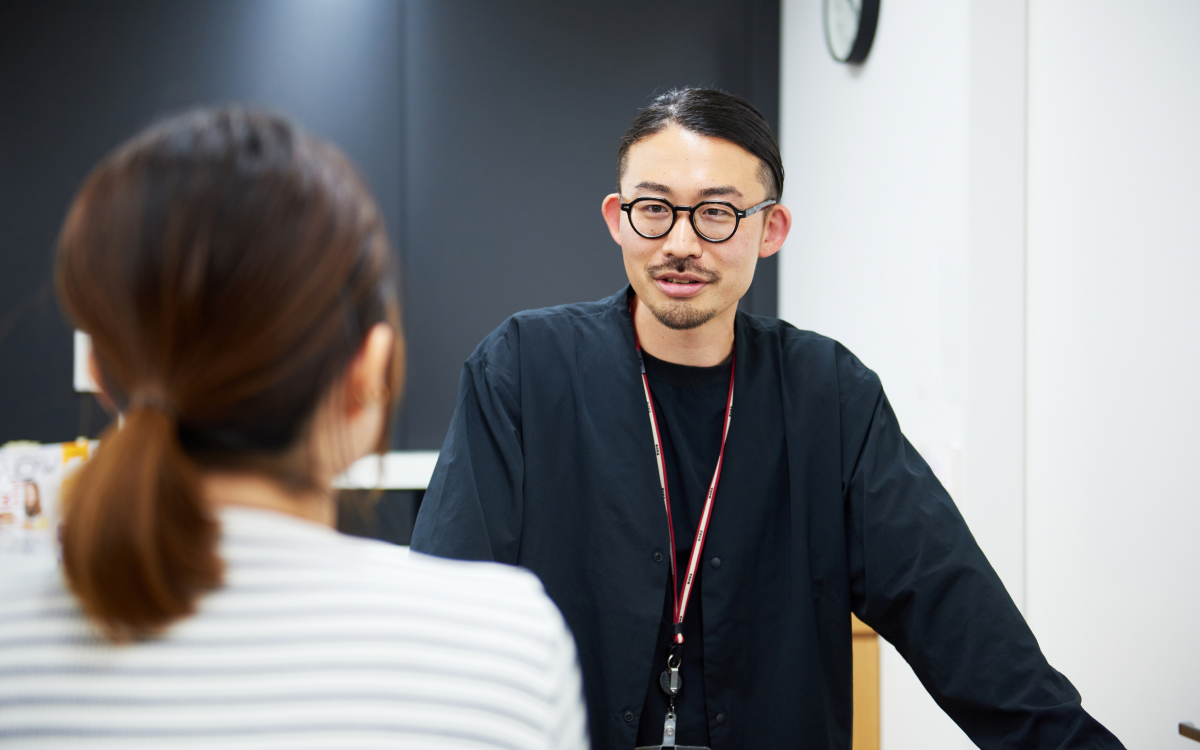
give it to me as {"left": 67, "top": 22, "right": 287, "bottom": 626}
{"left": 617, "top": 89, "right": 784, "bottom": 200}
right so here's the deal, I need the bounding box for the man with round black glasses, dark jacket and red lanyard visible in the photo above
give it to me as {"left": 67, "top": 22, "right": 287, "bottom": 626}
{"left": 413, "top": 89, "right": 1121, "bottom": 749}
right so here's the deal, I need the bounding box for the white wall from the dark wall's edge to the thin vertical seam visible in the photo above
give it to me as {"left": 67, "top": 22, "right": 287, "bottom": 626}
{"left": 780, "top": 0, "right": 1025, "bottom": 750}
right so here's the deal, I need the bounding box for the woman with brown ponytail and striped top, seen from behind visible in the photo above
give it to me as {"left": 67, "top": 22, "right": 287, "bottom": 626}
{"left": 0, "top": 109, "right": 586, "bottom": 748}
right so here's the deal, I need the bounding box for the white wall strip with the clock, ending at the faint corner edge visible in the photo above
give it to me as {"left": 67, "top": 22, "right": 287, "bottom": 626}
{"left": 779, "top": 0, "right": 967, "bottom": 518}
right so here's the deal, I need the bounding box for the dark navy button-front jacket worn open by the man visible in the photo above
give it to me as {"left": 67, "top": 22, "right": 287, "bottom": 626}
{"left": 413, "top": 288, "right": 1121, "bottom": 749}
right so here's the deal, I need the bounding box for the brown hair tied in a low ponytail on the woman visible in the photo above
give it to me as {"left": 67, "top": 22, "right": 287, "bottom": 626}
{"left": 55, "top": 108, "right": 403, "bottom": 641}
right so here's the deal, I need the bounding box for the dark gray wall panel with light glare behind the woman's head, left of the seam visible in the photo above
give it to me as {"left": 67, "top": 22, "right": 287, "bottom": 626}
{"left": 0, "top": 0, "right": 404, "bottom": 442}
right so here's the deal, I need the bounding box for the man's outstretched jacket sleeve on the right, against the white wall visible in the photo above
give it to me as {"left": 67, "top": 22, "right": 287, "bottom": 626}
{"left": 839, "top": 352, "right": 1122, "bottom": 749}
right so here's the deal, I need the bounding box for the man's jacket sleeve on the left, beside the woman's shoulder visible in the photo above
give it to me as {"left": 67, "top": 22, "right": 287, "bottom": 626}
{"left": 412, "top": 326, "right": 524, "bottom": 564}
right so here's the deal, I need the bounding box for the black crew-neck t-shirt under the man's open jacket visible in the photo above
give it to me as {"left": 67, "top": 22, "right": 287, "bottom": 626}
{"left": 637, "top": 352, "right": 733, "bottom": 745}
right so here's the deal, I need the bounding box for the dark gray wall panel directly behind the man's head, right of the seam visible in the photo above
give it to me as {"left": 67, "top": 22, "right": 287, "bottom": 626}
{"left": 400, "top": 0, "right": 779, "bottom": 448}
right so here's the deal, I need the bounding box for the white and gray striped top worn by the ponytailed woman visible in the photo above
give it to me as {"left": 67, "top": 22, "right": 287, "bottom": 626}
{"left": 0, "top": 509, "right": 587, "bottom": 750}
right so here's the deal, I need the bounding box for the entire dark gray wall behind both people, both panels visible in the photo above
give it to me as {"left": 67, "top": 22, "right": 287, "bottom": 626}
{"left": 0, "top": 0, "right": 779, "bottom": 449}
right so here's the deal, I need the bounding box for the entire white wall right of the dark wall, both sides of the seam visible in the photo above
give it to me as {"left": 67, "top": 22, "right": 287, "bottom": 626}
{"left": 780, "top": 0, "right": 1200, "bottom": 750}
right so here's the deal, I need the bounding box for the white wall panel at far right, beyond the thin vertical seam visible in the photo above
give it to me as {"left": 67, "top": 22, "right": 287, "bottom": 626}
{"left": 1027, "top": 0, "right": 1200, "bottom": 750}
